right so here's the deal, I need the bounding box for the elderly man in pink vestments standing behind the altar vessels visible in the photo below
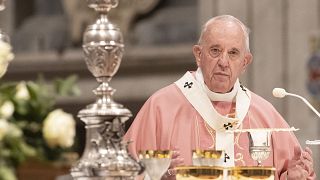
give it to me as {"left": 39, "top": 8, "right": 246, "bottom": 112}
{"left": 125, "top": 15, "right": 315, "bottom": 180}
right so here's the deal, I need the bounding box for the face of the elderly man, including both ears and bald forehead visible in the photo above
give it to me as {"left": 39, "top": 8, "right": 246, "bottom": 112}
{"left": 193, "top": 21, "right": 252, "bottom": 93}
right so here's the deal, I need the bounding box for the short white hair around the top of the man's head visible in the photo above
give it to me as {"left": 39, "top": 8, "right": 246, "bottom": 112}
{"left": 198, "top": 15, "right": 250, "bottom": 52}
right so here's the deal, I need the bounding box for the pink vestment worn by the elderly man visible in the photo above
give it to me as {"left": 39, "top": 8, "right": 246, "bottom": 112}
{"left": 124, "top": 76, "right": 315, "bottom": 179}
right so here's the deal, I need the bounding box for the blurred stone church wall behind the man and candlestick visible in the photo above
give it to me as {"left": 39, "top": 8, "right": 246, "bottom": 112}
{"left": 0, "top": 0, "right": 320, "bottom": 179}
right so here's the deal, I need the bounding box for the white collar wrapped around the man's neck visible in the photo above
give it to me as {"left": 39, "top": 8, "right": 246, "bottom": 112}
{"left": 196, "top": 68, "right": 240, "bottom": 102}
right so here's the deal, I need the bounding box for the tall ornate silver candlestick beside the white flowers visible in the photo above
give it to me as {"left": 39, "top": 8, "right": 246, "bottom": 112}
{"left": 71, "top": 0, "right": 141, "bottom": 180}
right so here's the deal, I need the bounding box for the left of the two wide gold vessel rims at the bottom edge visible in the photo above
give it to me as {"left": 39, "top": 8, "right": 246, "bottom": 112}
{"left": 175, "top": 166, "right": 223, "bottom": 180}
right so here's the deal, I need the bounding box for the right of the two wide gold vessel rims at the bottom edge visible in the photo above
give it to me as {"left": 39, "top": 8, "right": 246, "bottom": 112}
{"left": 228, "top": 166, "right": 276, "bottom": 180}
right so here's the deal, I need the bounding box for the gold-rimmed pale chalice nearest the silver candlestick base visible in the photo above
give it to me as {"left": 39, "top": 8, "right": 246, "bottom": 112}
{"left": 139, "top": 150, "right": 172, "bottom": 180}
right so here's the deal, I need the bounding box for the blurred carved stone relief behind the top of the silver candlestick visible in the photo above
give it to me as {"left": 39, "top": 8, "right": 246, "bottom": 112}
{"left": 12, "top": 0, "right": 198, "bottom": 53}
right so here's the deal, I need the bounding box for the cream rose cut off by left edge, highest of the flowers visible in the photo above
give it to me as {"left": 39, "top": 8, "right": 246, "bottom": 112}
{"left": 0, "top": 40, "right": 14, "bottom": 77}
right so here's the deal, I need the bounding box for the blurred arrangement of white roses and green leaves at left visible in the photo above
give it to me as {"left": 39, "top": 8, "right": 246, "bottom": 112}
{"left": 0, "top": 41, "right": 79, "bottom": 180}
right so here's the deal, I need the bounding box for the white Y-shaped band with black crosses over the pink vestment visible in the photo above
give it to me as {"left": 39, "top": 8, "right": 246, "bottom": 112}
{"left": 175, "top": 72, "right": 251, "bottom": 167}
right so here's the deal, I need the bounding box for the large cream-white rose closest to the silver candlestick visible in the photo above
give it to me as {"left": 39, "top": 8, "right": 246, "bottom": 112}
{"left": 42, "top": 109, "right": 75, "bottom": 148}
